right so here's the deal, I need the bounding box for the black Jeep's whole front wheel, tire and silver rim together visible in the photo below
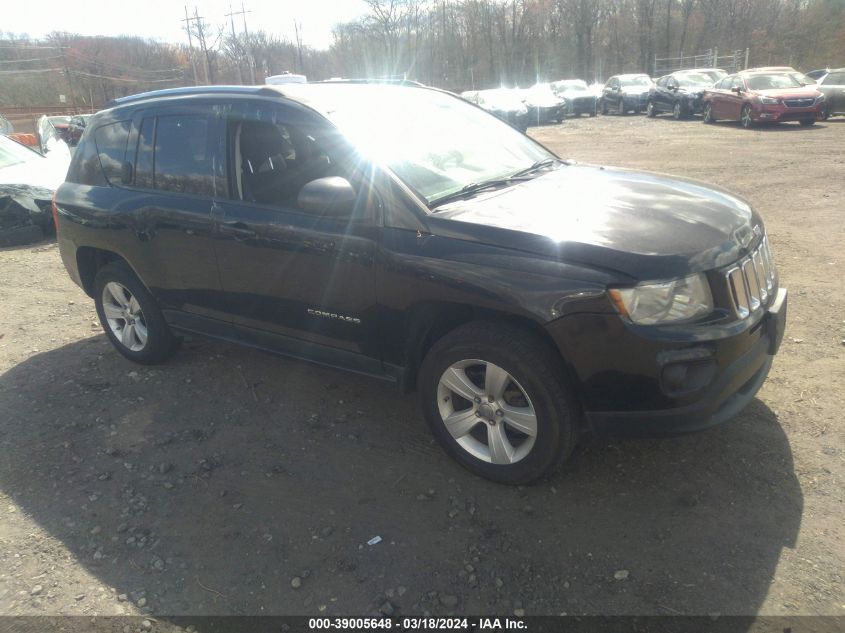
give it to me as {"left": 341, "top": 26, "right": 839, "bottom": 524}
{"left": 418, "top": 322, "right": 578, "bottom": 485}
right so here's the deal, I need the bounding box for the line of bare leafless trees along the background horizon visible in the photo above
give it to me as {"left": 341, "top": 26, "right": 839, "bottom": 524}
{"left": 0, "top": 0, "right": 845, "bottom": 108}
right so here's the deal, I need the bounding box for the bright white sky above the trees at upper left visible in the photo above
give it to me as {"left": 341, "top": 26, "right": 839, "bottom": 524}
{"left": 0, "top": 0, "right": 366, "bottom": 48}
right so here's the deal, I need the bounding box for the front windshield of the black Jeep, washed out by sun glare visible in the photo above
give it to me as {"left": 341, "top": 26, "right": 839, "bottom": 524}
{"left": 320, "top": 86, "right": 553, "bottom": 205}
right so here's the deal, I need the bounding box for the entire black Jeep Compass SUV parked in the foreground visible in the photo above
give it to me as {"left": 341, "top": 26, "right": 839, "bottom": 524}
{"left": 54, "top": 84, "right": 786, "bottom": 483}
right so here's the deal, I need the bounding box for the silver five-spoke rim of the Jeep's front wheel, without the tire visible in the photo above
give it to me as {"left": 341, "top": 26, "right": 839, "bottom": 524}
{"left": 437, "top": 359, "right": 537, "bottom": 465}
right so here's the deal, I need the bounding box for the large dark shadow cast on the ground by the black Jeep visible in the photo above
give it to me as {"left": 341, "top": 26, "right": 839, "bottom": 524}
{"left": 0, "top": 335, "right": 803, "bottom": 615}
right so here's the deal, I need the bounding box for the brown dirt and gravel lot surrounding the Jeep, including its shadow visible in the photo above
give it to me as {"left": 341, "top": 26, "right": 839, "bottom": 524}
{"left": 0, "top": 116, "right": 845, "bottom": 615}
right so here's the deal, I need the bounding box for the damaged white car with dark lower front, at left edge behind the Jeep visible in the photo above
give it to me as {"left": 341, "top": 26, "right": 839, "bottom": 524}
{"left": 0, "top": 136, "right": 70, "bottom": 246}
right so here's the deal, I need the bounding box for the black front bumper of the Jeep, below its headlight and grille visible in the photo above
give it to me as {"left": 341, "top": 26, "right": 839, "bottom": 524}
{"left": 550, "top": 288, "right": 787, "bottom": 436}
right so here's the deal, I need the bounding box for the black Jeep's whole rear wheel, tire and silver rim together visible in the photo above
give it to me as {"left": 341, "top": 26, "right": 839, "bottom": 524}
{"left": 94, "top": 262, "right": 181, "bottom": 365}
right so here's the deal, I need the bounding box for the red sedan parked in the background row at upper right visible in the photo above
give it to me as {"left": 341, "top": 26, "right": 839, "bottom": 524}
{"left": 703, "top": 70, "right": 825, "bottom": 128}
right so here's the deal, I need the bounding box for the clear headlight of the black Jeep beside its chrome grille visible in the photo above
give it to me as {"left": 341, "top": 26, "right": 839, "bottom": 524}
{"left": 610, "top": 273, "right": 713, "bottom": 325}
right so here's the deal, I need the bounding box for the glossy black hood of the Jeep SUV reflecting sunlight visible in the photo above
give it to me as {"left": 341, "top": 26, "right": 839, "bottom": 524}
{"left": 430, "top": 165, "right": 763, "bottom": 280}
